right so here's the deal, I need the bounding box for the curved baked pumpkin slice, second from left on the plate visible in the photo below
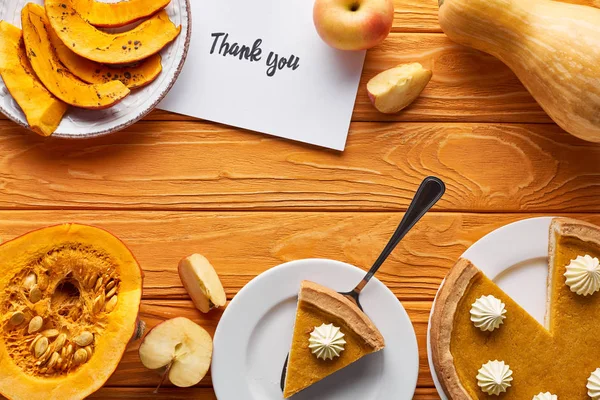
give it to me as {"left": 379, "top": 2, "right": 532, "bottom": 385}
{"left": 21, "top": 3, "right": 130, "bottom": 109}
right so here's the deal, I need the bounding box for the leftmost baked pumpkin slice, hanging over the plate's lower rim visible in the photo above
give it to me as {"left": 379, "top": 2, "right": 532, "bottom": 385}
{"left": 0, "top": 21, "right": 68, "bottom": 136}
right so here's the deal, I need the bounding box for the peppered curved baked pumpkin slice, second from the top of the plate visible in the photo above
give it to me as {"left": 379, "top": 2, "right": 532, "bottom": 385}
{"left": 45, "top": 0, "right": 181, "bottom": 64}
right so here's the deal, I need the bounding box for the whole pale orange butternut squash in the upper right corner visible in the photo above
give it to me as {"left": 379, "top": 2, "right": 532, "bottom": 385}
{"left": 439, "top": 0, "right": 600, "bottom": 142}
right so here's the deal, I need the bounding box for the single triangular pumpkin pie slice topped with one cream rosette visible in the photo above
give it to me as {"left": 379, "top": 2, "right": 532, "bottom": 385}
{"left": 283, "top": 281, "right": 385, "bottom": 398}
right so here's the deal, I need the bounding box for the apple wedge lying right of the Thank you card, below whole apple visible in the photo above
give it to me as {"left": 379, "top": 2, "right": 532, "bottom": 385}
{"left": 367, "top": 63, "right": 432, "bottom": 114}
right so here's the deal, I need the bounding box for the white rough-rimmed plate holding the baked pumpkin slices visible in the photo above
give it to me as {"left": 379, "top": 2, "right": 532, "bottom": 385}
{"left": 0, "top": 0, "right": 191, "bottom": 139}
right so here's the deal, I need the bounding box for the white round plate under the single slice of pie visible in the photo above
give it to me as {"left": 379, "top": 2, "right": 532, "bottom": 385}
{"left": 212, "top": 259, "right": 419, "bottom": 400}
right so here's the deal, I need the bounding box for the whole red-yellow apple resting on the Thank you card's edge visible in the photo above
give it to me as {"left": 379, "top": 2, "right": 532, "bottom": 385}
{"left": 313, "top": 0, "right": 394, "bottom": 50}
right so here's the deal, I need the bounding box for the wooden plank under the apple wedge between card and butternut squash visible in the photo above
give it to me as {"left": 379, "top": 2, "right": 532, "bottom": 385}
{"left": 147, "top": 32, "right": 551, "bottom": 123}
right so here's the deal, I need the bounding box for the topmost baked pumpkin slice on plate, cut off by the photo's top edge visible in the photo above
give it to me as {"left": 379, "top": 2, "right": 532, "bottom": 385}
{"left": 72, "top": 0, "right": 171, "bottom": 28}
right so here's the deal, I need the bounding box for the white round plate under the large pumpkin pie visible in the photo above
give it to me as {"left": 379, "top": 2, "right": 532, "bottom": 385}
{"left": 427, "top": 217, "right": 552, "bottom": 400}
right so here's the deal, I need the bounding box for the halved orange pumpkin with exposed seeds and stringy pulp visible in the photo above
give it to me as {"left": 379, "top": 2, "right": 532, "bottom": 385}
{"left": 0, "top": 224, "right": 143, "bottom": 400}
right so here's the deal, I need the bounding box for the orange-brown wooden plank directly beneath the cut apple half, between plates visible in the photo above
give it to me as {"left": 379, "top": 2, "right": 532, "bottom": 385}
{"left": 106, "top": 300, "right": 433, "bottom": 388}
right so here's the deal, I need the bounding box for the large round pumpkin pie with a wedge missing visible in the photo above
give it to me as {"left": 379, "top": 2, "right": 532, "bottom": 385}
{"left": 431, "top": 218, "right": 600, "bottom": 400}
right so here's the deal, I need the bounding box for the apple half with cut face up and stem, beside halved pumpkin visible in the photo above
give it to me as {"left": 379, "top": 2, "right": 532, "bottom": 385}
{"left": 139, "top": 317, "right": 213, "bottom": 390}
